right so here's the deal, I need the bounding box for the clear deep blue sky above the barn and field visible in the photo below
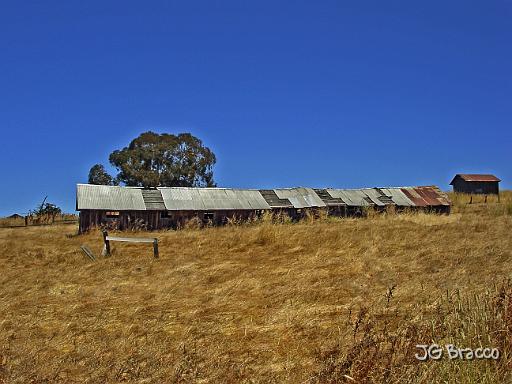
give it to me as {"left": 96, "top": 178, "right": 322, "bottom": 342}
{"left": 0, "top": 0, "right": 512, "bottom": 215}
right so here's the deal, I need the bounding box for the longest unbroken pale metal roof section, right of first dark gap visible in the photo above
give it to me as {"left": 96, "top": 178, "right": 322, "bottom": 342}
{"left": 158, "top": 187, "right": 270, "bottom": 211}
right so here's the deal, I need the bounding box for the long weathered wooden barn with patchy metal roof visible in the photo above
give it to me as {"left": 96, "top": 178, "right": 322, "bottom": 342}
{"left": 76, "top": 184, "right": 450, "bottom": 233}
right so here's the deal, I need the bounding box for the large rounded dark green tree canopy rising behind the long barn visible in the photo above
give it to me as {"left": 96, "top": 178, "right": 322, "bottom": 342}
{"left": 89, "top": 132, "right": 216, "bottom": 187}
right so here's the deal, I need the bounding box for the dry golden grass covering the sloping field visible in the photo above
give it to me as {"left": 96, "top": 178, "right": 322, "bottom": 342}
{"left": 0, "top": 192, "right": 512, "bottom": 383}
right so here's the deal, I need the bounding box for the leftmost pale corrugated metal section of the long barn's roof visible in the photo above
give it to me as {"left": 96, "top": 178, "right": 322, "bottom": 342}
{"left": 76, "top": 184, "right": 146, "bottom": 211}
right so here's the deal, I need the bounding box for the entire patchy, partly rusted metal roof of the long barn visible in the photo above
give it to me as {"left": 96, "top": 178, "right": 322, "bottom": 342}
{"left": 77, "top": 184, "right": 451, "bottom": 211}
